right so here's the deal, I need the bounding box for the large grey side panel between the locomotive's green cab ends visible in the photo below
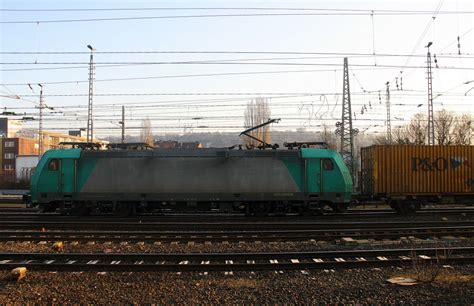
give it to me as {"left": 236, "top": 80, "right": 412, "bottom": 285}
{"left": 81, "top": 155, "right": 300, "bottom": 194}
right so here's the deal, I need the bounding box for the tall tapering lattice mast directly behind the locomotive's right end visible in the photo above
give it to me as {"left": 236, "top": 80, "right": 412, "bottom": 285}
{"left": 336, "top": 57, "right": 359, "bottom": 180}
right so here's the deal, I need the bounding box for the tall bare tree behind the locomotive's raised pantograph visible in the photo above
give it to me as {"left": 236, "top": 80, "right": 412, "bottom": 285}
{"left": 244, "top": 98, "right": 271, "bottom": 148}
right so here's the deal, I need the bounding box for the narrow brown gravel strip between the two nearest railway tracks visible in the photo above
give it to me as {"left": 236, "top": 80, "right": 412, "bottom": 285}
{"left": 0, "top": 237, "right": 474, "bottom": 253}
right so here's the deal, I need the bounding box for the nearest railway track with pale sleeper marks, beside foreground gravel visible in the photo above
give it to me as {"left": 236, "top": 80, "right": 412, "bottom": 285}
{"left": 0, "top": 247, "right": 474, "bottom": 272}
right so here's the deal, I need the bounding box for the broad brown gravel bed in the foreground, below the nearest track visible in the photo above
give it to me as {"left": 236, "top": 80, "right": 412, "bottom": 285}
{"left": 0, "top": 266, "right": 474, "bottom": 304}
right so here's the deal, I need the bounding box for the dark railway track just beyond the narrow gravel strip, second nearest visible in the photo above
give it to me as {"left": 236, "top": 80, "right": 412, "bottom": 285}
{"left": 0, "top": 225, "right": 474, "bottom": 243}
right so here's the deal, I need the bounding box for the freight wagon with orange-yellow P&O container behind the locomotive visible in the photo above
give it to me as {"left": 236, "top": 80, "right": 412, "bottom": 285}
{"left": 359, "top": 145, "right": 474, "bottom": 212}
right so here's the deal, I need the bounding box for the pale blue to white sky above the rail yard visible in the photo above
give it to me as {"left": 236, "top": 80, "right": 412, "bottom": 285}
{"left": 0, "top": 0, "right": 474, "bottom": 136}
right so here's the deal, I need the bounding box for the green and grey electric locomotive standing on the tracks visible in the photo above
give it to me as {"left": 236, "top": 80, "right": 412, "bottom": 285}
{"left": 25, "top": 148, "right": 352, "bottom": 216}
